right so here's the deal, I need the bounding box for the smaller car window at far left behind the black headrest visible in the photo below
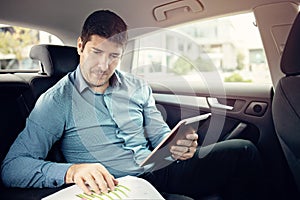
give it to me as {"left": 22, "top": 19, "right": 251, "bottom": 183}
{"left": 0, "top": 24, "right": 63, "bottom": 70}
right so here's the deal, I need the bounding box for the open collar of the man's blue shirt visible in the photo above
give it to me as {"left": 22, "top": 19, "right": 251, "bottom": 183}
{"left": 73, "top": 65, "right": 122, "bottom": 93}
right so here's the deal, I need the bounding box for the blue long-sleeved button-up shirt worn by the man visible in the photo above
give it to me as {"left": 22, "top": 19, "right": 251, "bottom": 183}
{"left": 1, "top": 67, "right": 170, "bottom": 187}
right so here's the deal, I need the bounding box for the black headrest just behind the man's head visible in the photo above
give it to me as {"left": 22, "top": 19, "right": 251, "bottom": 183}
{"left": 30, "top": 44, "right": 79, "bottom": 76}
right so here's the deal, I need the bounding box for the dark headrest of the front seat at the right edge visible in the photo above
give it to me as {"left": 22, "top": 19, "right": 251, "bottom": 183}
{"left": 280, "top": 13, "right": 300, "bottom": 76}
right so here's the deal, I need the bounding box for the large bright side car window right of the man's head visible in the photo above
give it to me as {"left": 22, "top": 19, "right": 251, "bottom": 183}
{"left": 126, "top": 13, "right": 271, "bottom": 84}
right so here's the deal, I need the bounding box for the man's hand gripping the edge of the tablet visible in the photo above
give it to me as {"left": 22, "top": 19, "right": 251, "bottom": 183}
{"left": 170, "top": 131, "right": 198, "bottom": 160}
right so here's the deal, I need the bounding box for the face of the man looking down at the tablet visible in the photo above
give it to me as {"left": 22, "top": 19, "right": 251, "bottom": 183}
{"left": 77, "top": 35, "right": 123, "bottom": 92}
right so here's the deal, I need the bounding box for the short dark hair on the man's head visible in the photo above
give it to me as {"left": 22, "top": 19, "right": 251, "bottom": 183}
{"left": 81, "top": 10, "right": 128, "bottom": 48}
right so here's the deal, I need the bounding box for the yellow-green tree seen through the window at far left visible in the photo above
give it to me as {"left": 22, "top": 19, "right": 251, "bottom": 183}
{"left": 0, "top": 27, "right": 38, "bottom": 68}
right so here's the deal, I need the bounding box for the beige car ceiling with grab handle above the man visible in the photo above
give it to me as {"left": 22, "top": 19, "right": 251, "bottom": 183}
{"left": 0, "top": 0, "right": 299, "bottom": 45}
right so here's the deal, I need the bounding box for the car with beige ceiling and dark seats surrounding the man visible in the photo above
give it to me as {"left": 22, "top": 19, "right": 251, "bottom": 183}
{"left": 0, "top": 0, "right": 300, "bottom": 199}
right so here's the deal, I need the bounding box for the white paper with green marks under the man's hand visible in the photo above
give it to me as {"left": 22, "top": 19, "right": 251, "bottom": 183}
{"left": 43, "top": 176, "right": 164, "bottom": 200}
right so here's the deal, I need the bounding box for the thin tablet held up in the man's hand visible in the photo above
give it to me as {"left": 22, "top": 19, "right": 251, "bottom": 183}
{"left": 140, "top": 113, "right": 211, "bottom": 169}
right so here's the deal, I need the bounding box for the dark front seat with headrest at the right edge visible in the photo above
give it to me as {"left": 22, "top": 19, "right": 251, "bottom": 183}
{"left": 272, "top": 11, "right": 300, "bottom": 191}
